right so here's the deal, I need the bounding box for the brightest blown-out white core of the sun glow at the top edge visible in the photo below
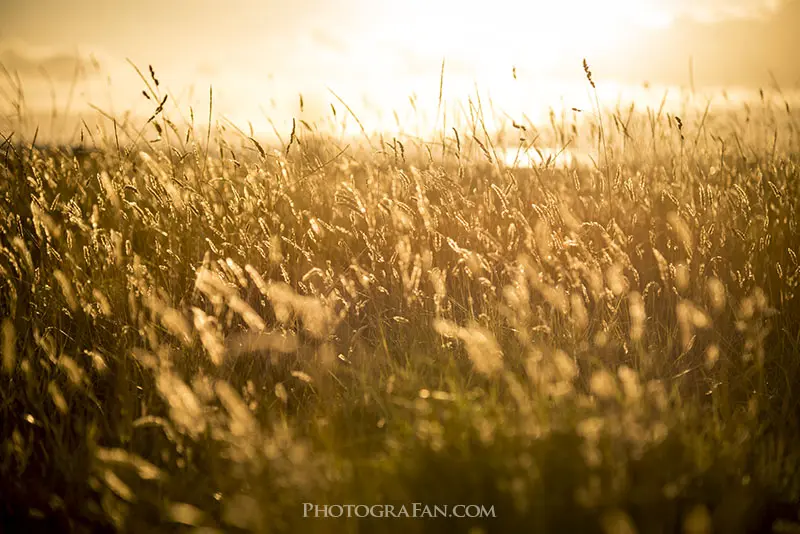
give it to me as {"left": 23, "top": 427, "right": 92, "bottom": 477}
{"left": 373, "top": 0, "right": 669, "bottom": 76}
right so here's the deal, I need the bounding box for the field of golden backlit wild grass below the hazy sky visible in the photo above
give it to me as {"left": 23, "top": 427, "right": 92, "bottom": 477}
{"left": 0, "top": 72, "right": 800, "bottom": 534}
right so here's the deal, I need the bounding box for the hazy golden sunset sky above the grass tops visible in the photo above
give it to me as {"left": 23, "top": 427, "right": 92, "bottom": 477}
{"left": 0, "top": 0, "right": 800, "bottom": 140}
